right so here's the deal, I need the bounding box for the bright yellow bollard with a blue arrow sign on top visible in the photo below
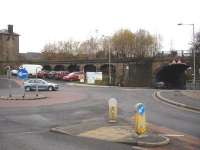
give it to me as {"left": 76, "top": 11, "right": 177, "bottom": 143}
{"left": 133, "top": 103, "right": 146, "bottom": 135}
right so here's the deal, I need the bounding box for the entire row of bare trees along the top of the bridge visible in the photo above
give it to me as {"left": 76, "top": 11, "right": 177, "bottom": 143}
{"left": 42, "top": 29, "right": 161, "bottom": 60}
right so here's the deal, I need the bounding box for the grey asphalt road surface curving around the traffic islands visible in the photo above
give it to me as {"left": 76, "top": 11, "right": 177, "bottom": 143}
{"left": 0, "top": 81, "right": 200, "bottom": 150}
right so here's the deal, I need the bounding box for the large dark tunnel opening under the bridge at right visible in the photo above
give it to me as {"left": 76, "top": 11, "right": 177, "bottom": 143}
{"left": 155, "top": 64, "right": 189, "bottom": 89}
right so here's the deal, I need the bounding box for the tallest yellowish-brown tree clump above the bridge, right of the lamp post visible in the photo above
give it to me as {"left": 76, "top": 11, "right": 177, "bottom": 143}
{"left": 112, "top": 29, "right": 161, "bottom": 58}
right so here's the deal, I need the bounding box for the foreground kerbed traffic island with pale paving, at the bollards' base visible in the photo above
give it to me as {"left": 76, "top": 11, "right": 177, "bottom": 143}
{"left": 50, "top": 119, "right": 170, "bottom": 147}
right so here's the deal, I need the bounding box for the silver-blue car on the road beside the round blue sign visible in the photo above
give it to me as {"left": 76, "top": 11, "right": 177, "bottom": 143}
{"left": 24, "top": 79, "right": 59, "bottom": 91}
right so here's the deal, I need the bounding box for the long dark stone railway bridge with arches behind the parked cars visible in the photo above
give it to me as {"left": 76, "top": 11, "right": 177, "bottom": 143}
{"left": 0, "top": 57, "right": 200, "bottom": 87}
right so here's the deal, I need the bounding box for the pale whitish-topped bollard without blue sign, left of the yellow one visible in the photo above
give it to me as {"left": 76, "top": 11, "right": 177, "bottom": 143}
{"left": 108, "top": 98, "right": 117, "bottom": 123}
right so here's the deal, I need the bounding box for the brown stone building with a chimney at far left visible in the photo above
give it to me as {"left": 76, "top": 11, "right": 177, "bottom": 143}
{"left": 0, "top": 25, "right": 19, "bottom": 62}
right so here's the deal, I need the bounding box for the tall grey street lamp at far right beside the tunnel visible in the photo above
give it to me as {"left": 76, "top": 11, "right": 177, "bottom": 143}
{"left": 178, "top": 23, "right": 196, "bottom": 87}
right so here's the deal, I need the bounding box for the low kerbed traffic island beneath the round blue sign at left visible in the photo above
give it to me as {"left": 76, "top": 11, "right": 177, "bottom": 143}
{"left": 0, "top": 95, "right": 47, "bottom": 100}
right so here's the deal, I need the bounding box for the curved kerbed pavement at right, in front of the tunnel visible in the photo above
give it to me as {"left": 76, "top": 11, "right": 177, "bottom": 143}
{"left": 156, "top": 90, "right": 200, "bottom": 112}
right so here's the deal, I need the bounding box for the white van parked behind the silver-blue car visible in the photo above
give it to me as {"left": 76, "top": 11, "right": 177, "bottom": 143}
{"left": 19, "top": 64, "right": 43, "bottom": 76}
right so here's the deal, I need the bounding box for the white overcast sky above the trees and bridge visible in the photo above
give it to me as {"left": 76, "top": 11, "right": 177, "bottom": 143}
{"left": 0, "top": 0, "right": 200, "bottom": 52}
